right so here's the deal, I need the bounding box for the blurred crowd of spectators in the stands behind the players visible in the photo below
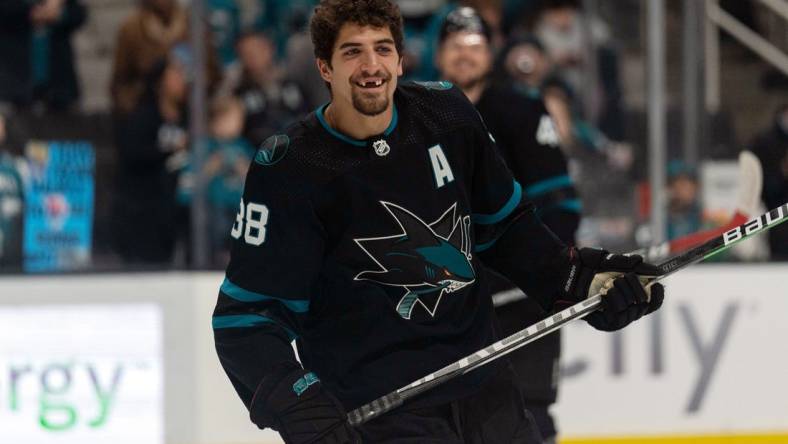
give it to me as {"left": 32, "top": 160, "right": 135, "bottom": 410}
{"left": 0, "top": 0, "right": 788, "bottom": 268}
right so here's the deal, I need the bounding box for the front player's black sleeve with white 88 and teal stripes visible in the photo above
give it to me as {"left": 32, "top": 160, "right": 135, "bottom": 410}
{"left": 213, "top": 153, "right": 324, "bottom": 407}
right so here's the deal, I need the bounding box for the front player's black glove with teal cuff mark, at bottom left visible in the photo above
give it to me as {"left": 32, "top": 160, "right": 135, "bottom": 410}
{"left": 249, "top": 362, "right": 361, "bottom": 444}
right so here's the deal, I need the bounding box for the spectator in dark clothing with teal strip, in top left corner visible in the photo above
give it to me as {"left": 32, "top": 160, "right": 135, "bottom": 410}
{"left": 0, "top": 0, "right": 87, "bottom": 111}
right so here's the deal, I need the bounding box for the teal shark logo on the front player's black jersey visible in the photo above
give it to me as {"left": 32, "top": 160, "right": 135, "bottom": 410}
{"left": 354, "top": 201, "right": 476, "bottom": 319}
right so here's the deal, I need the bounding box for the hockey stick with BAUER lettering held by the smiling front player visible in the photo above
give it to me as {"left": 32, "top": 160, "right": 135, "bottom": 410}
{"left": 348, "top": 203, "right": 788, "bottom": 426}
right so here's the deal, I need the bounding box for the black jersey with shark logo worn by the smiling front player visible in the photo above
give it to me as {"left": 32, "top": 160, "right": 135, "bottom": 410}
{"left": 213, "top": 82, "right": 567, "bottom": 410}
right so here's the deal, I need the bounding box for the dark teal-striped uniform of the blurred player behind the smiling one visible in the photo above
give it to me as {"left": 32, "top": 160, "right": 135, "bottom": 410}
{"left": 476, "top": 86, "right": 580, "bottom": 437}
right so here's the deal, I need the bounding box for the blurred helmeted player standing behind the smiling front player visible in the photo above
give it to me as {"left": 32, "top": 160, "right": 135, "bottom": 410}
{"left": 436, "top": 7, "right": 580, "bottom": 442}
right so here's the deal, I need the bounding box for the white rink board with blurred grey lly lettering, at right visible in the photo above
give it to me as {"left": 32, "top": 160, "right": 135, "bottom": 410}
{"left": 554, "top": 264, "right": 788, "bottom": 442}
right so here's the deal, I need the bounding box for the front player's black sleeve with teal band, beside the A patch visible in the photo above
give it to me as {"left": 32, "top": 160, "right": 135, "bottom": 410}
{"left": 471, "top": 106, "right": 568, "bottom": 310}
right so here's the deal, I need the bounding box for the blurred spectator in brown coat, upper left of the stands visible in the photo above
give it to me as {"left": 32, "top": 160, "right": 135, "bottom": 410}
{"left": 110, "top": 0, "right": 188, "bottom": 115}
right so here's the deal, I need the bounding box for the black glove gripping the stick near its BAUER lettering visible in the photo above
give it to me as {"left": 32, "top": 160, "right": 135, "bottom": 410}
{"left": 564, "top": 248, "right": 665, "bottom": 331}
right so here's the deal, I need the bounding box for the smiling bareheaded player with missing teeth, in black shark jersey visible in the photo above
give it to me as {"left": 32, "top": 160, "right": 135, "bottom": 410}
{"left": 213, "top": 0, "right": 663, "bottom": 443}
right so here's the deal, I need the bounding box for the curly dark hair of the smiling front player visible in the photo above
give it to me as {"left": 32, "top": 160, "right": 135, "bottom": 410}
{"left": 309, "top": 0, "right": 403, "bottom": 66}
